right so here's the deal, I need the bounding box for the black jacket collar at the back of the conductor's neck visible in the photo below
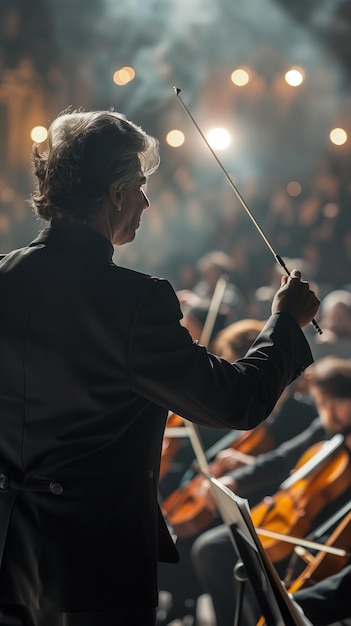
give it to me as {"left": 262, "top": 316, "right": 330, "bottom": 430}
{"left": 29, "top": 219, "right": 114, "bottom": 261}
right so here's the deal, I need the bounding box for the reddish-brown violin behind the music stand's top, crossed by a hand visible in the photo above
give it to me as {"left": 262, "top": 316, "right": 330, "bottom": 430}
{"left": 162, "top": 423, "right": 275, "bottom": 538}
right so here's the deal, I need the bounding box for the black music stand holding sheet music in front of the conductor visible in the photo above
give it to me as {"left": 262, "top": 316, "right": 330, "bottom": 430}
{"left": 208, "top": 476, "right": 312, "bottom": 626}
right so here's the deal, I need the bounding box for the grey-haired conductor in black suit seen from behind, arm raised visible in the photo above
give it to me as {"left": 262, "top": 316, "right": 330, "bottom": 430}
{"left": 0, "top": 110, "right": 319, "bottom": 626}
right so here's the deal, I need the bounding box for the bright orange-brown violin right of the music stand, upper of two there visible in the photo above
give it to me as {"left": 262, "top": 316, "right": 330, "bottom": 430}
{"left": 251, "top": 435, "right": 351, "bottom": 563}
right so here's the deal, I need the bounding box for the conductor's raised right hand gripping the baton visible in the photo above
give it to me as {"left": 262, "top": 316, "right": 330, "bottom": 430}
{"left": 272, "top": 269, "right": 320, "bottom": 328}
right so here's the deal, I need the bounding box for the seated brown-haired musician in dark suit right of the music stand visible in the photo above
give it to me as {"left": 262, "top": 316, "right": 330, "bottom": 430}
{"left": 192, "top": 357, "right": 351, "bottom": 626}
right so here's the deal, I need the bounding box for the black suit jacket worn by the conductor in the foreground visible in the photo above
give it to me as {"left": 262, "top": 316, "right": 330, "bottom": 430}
{"left": 0, "top": 221, "right": 312, "bottom": 611}
